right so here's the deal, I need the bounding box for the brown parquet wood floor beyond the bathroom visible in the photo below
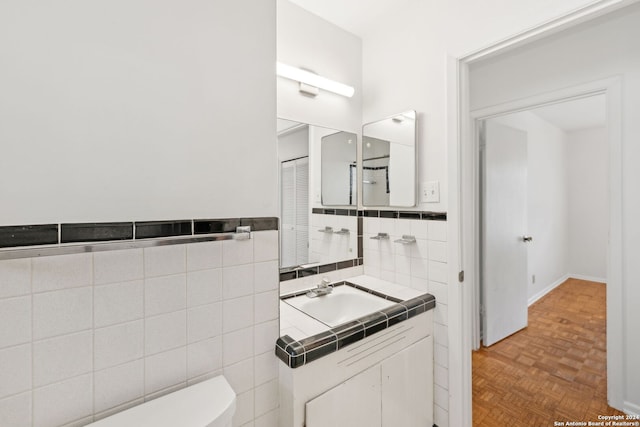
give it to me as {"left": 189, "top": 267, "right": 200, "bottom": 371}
{"left": 472, "top": 279, "right": 622, "bottom": 427}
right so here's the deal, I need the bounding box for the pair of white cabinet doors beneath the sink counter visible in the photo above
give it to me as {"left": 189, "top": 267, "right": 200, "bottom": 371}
{"left": 305, "top": 336, "right": 433, "bottom": 427}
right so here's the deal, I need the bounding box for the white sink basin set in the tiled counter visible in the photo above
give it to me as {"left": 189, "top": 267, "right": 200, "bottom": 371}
{"left": 283, "top": 285, "right": 395, "bottom": 327}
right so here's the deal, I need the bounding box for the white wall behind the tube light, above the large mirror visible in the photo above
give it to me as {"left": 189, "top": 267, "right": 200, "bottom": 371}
{"left": 277, "top": 0, "right": 362, "bottom": 134}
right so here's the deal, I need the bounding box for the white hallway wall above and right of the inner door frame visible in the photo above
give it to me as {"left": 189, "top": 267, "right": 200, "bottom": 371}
{"left": 470, "top": 1, "right": 640, "bottom": 413}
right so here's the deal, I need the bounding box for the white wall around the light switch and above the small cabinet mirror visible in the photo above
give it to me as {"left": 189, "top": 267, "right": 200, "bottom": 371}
{"left": 362, "top": 0, "right": 604, "bottom": 211}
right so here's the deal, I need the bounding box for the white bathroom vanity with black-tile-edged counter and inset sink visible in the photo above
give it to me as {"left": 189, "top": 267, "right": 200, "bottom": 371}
{"left": 276, "top": 276, "right": 435, "bottom": 427}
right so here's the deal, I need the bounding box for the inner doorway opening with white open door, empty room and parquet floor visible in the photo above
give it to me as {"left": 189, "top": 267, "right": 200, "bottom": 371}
{"left": 472, "top": 93, "right": 621, "bottom": 426}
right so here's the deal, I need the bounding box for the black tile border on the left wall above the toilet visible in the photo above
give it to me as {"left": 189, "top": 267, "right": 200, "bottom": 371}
{"left": 0, "top": 217, "right": 279, "bottom": 259}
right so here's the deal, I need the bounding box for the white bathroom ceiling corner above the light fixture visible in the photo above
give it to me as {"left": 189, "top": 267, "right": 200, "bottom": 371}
{"left": 290, "top": 0, "right": 415, "bottom": 37}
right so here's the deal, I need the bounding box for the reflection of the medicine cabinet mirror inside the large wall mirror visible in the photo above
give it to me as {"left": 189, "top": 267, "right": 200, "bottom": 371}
{"left": 320, "top": 132, "right": 358, "bottom": 206}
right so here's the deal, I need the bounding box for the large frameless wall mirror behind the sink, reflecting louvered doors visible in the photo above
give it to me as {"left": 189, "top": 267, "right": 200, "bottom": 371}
{"left": 277, "top": 119, "right": 358, "bottom": 270}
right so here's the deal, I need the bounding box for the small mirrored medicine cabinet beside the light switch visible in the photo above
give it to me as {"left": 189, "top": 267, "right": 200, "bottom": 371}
{"left": 362, "top": 110, "right": 416, "bottom": 207}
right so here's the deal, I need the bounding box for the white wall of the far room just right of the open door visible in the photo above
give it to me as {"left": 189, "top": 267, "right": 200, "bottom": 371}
{"left": 492, "top": 111, "right": 570, "bottom": 299}
